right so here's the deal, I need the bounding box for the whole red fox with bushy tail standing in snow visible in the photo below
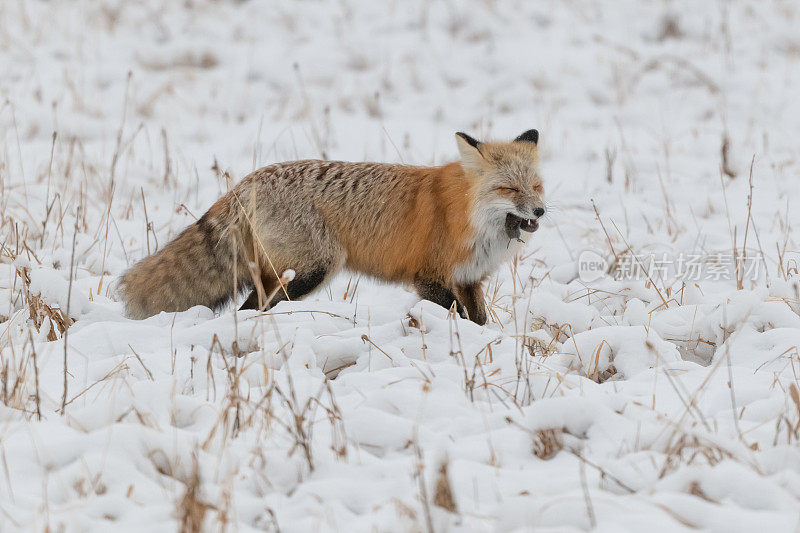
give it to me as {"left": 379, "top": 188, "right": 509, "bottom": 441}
{"left": 120, "top": 130, "right": 545, "bottom": 324}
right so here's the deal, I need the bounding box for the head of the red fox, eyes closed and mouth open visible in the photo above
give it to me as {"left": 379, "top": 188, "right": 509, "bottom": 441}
{"left": 456, "top": 130, "right": 545, "bottom": 239}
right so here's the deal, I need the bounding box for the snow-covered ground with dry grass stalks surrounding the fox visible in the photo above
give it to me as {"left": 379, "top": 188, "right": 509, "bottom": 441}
{"left": 0, "top": 0, "right": 800, "bottom": 532}
